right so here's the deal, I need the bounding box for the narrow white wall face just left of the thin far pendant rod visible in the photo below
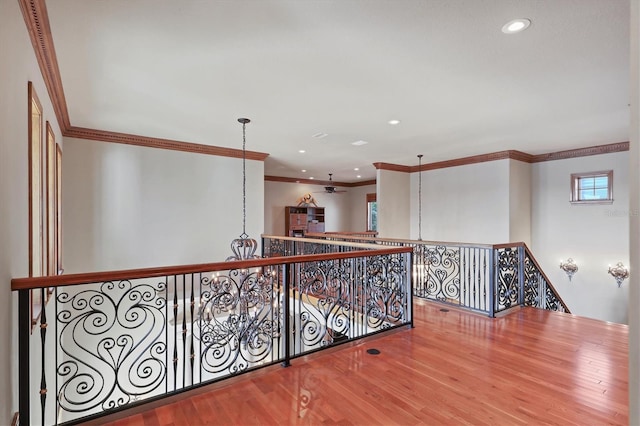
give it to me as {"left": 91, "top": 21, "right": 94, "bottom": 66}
{"left": 376, "top": 170, "right": 410, "bottom": 239}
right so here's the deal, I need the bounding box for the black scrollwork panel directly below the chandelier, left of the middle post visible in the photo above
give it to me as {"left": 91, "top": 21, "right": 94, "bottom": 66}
{"left": 194, "top": 269, "right": 281, "bottom": 374}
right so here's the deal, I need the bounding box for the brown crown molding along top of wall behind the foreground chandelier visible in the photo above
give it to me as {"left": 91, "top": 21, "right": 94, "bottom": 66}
{"left": 65, "top": 126, "right": 269, "bottom": 161}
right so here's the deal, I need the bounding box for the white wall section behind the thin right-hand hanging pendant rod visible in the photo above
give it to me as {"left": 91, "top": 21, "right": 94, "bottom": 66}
{"left": 409, "top": 160, "right": 510, "bottom": 244}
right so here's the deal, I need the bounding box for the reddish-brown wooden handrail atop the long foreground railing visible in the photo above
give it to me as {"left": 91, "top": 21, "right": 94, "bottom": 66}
{"left": 11, "top": 246, "right": 412, "bottom": 291}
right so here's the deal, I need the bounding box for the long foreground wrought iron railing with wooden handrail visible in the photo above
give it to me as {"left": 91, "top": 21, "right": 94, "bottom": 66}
{"left": 12, "top": 243, "right": 412, "bottom": 425}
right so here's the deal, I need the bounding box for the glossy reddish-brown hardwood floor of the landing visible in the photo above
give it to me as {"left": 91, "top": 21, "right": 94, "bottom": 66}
{"left": 100, "top": 301, "right": 629, "bottom": 426}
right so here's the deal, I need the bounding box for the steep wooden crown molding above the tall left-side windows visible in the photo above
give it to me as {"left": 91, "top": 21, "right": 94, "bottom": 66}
{"left": 18, "top": 0, "right": 71, "bottom": 131}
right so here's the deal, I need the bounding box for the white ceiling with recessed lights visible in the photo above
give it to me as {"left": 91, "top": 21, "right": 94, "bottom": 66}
{"left": 47, "top": 0, "right": 629, "bottom": 182}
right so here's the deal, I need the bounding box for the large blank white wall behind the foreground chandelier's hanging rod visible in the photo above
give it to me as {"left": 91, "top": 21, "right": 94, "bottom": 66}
{"left": 63, "top": 138, "right": 264, "bottom": 273}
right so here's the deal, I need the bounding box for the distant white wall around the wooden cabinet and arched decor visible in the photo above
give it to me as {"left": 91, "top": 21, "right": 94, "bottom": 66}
{"left": 264, "top": 181, "right": 353, "bottom": 235}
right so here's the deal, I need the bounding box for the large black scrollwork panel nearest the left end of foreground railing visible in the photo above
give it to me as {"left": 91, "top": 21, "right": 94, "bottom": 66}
{"left": 57, "top": 281, "right": 167, "bottom": 413}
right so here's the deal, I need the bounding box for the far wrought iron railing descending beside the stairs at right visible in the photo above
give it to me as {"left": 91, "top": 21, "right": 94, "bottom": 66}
{"left": 307, "top": 233, "right": 570, "bottom": 316}
